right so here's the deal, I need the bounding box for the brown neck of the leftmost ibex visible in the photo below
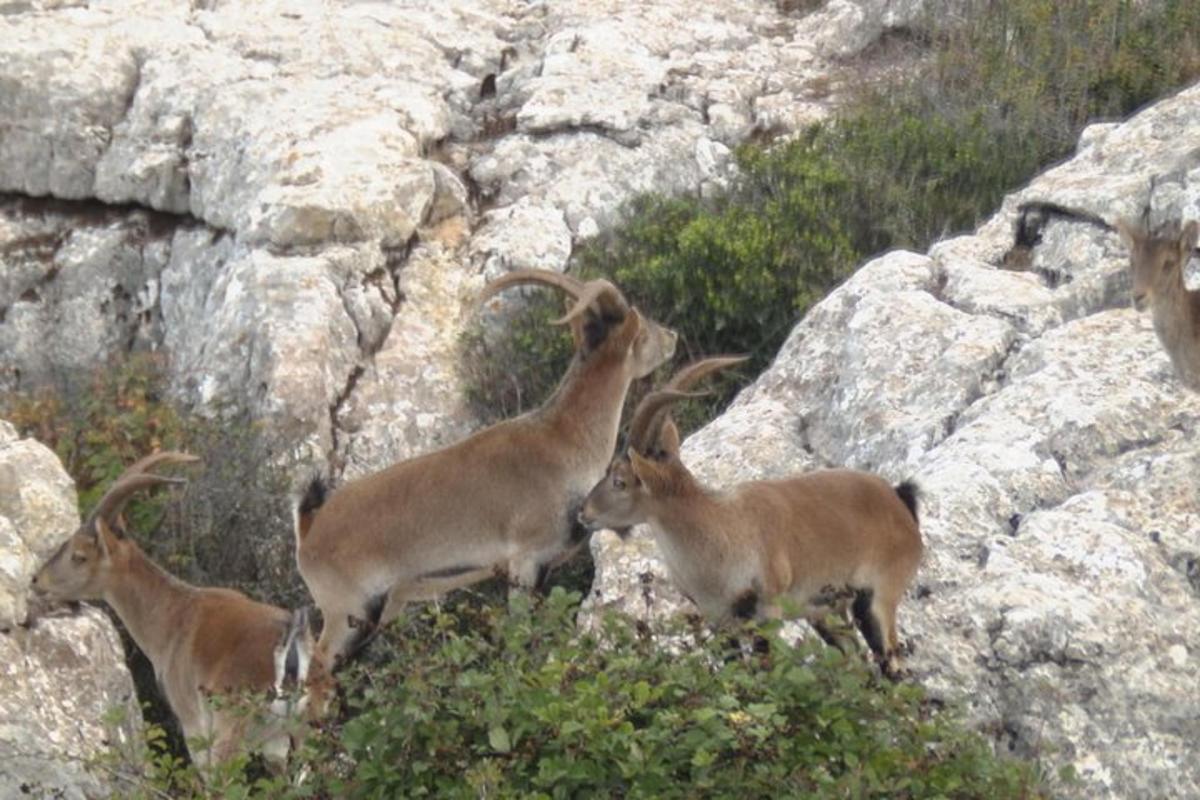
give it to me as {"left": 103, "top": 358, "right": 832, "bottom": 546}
{"left": 104, "top": 542, "right": 196, "bottom": 673}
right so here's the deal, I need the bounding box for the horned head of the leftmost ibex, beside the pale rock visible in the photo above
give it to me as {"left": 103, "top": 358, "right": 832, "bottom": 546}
{"left": 32, "top": 452, "right": 199, "bottom": 601}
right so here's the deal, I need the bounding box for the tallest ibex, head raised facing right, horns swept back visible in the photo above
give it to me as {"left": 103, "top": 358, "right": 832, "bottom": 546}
{"left": 295, "top": 270, "right": 676, "bottom": 663}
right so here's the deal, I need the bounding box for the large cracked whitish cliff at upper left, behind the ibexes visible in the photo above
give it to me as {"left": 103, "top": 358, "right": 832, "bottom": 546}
{"left": 0, "top": 0, "right": 922, "bottom": 470}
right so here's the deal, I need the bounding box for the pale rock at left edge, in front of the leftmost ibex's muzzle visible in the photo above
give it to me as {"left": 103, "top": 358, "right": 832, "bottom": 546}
{"left": 0, "top": 420, "right": 142, "bottom": 799}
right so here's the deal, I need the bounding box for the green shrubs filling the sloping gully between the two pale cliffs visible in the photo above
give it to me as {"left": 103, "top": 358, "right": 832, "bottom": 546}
{"left": 464, "top": 0, "right": 1200, "bottom": 427}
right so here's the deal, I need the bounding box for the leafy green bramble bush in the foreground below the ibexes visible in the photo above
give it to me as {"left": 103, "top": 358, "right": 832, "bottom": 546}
{"left": 108, "top": 589, "right": 1044, "bottom": 798}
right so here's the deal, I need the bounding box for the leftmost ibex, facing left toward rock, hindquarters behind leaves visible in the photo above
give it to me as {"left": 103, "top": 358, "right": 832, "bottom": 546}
{"left": 32, "top": 452, "right": 332, "bottom": 766}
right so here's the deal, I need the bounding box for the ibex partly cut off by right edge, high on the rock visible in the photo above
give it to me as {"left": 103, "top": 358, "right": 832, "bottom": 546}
{"left": 1116, "top": 219, "right": 1200, "bottom": 391}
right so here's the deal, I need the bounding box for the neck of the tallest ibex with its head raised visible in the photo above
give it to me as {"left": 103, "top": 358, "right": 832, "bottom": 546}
{"left": 542, "top": 354, "right": 632, "bottom": 461}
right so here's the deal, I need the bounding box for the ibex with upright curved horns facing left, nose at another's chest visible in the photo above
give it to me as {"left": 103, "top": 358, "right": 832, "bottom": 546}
{"left": 580, "top": 357, "right": 923, "bottom": 674}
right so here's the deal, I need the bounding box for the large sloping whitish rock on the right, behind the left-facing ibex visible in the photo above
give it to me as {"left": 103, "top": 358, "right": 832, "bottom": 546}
{"left": 592, "top": 79, "right": 1200, "bottom": 798}
